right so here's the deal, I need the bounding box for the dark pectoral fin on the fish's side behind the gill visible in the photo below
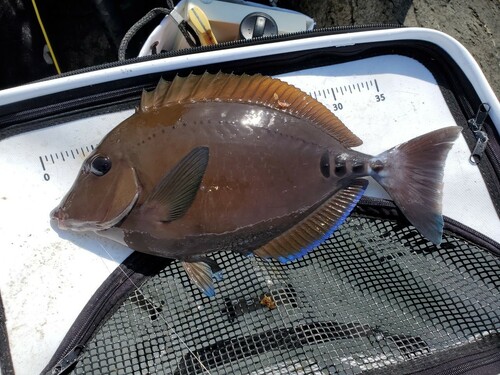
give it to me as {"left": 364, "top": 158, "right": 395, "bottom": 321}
{"left": 144, "top": 146, "right": 208, "bottom": 221}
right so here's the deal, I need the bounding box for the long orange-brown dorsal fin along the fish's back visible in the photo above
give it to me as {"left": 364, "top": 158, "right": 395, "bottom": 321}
{"left": 140, "top": 72, "right": 362, "bottom": 147}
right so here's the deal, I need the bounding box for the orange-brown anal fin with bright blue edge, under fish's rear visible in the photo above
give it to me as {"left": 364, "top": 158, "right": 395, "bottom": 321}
{"left": 254, "top": 179, "right": 368, "bottom": 263}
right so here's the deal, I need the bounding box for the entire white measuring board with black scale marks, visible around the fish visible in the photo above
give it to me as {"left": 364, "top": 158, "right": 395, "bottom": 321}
{"left": 0, "top": 56, "right": 500, "bottom": 375}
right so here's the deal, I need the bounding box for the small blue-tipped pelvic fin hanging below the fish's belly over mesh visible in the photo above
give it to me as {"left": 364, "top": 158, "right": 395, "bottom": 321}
{"left": 181, "top": 257, "right": 222, "bottom": 297}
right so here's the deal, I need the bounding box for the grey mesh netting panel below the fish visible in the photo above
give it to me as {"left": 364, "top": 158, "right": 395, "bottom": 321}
{"left": 73, "top": 217, "right": 500, "bottom": 375}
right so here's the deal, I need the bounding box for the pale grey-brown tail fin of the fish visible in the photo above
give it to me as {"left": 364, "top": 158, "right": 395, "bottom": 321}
{"left": 371, "top": 126, "right": 461, "bottom": 245}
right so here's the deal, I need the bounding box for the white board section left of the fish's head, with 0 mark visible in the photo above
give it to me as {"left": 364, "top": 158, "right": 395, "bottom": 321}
{"left": 0, "top": 111, "right": 131, "bottom": 375}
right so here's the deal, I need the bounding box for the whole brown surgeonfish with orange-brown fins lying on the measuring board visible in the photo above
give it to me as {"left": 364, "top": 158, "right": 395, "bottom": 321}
{"left": 50, "top": 72, "right": 461, "bottom": 296}
